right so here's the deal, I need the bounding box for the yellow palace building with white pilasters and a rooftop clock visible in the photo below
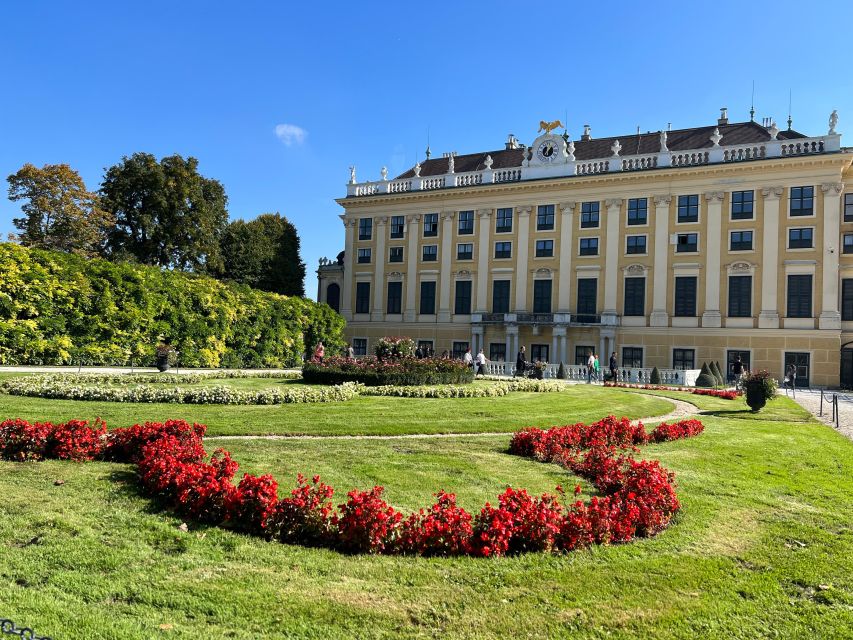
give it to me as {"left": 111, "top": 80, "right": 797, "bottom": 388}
{"left": 318, "top": 109, "right": 853, "bottom": 386}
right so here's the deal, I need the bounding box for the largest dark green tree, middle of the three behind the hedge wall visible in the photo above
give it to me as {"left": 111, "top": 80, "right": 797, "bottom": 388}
{"left": 101, "top": 153, "right": 228, "bottom": 272}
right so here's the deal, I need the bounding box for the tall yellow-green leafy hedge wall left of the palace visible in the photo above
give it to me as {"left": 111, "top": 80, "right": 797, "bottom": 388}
{"left": 0, "top": 243, "right": 344, "bottom": 367}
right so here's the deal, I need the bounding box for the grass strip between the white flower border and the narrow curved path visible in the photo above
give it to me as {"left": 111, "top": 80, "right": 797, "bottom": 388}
{"left": 0, "top": 383, "right": 672, "bottom": 435}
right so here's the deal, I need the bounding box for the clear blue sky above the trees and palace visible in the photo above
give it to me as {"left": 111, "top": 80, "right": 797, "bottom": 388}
{"left": 0, "top": 0, "right": 853, "bottom": 295}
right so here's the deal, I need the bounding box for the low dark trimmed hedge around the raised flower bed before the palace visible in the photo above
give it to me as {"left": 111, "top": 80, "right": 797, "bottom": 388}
{"left": 302, "top": 357, "right": 474, "bottom": 387}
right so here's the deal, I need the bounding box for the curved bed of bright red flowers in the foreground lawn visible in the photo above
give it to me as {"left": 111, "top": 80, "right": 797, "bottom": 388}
{"left": 0, "top": 416, "right": 703, "bottom": 557}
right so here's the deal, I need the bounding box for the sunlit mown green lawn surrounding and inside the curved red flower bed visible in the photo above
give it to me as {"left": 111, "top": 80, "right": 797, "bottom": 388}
{"left": 0, "top": 387, "right": 853, "bottom": 639}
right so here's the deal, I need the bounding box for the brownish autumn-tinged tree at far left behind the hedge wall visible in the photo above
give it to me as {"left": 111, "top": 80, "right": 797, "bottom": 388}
{"left": 7, "top": 163, "right": 112, "bottom": 256}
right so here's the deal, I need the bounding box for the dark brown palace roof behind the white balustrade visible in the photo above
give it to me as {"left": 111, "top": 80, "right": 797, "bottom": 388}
{"left": 396, "top": 122, "right": 806, "bottom": 179}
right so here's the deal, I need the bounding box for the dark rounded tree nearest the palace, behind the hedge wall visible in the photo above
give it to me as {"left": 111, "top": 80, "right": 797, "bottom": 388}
{"left": 220, "top": 213, "right": 305, "bottom": 296}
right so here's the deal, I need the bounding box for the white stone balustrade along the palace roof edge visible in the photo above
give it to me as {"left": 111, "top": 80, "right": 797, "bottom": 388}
{"left": 347, "top": 134, "right": 841, "bottom": 197}
